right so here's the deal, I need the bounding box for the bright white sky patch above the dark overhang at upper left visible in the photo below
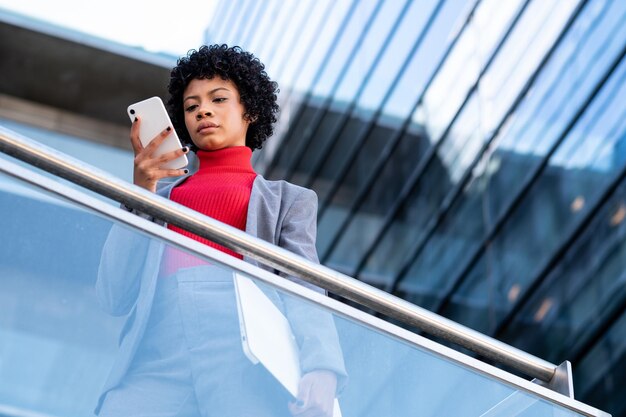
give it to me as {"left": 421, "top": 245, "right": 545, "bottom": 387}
{"left": 0, "top": 0, "right": 218, "bottom": 56}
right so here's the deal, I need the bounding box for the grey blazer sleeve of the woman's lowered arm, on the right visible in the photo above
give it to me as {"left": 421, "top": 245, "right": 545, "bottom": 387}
{"left": 279, "top": 189, "right": 347, "bottom": 391}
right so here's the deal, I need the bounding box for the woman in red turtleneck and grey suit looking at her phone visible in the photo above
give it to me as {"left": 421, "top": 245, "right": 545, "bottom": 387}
{"left": 96, "top": 45, "right": 346, "bottom": 416}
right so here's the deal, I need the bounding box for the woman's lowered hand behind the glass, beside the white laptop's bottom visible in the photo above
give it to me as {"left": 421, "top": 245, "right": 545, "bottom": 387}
{"left": 289, "top": 370, "right": 337, "bottom": 417}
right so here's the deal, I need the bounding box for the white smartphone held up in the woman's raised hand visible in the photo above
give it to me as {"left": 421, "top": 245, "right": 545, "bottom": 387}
{"left": 127, "top": 97, "right": 189, "bottom": 169}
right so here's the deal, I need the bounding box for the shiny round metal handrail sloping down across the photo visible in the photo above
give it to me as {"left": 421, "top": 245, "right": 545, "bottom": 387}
{"left": 0, "top": 126, "right": 557, "bottom": 383}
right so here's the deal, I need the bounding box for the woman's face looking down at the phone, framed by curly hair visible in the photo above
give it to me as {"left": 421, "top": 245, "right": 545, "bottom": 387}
{"left": 183, "top": 77, "right": 250, "bottom": 151}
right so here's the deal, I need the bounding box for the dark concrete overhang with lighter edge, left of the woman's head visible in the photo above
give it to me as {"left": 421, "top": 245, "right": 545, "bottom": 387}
{"left": 0, "top": 9, "right": 176, "bottom": 126}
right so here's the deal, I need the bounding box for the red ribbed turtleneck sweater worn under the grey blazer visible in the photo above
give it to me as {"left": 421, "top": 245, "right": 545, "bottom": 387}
{"left": 161, "top": 146, "right": 256, "bottom": 276}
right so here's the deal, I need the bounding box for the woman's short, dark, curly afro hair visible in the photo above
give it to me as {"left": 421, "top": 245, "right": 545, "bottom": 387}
{"left": 167, "top": 45, "right": 278, "bottom": 152}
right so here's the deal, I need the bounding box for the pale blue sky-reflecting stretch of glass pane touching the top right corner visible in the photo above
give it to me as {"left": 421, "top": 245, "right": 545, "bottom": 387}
{"left": 500, "top": 1, "right": 624, "bottom": 162}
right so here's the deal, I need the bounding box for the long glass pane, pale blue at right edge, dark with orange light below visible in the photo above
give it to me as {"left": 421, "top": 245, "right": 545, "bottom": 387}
{"left": 438, "top": 55, "right": 626, "bottom": 326}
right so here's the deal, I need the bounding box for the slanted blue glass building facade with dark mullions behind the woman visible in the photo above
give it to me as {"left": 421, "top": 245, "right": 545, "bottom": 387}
{"left": 205, "top": 0, "right": 626, "bottom": 416}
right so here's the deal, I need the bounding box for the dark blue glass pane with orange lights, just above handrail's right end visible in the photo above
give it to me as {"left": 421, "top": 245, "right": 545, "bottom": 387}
{"left": 502, "top": 176, "right": 626, "bottom": 361}
